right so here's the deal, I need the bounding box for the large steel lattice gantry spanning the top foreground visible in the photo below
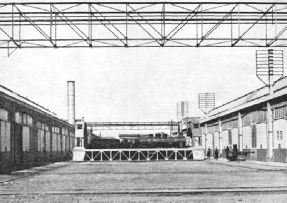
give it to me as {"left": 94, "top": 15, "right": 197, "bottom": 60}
{"left": 0, "top": 2, "right": 287, "bottom": 50}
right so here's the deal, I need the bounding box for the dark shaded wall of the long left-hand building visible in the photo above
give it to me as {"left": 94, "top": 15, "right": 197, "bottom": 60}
{"left": 0, "top": 92, "right": 75, "bottom": 174}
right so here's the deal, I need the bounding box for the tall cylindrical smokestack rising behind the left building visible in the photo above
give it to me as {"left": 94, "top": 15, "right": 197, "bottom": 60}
{"left": 67, "top": 81, "right": 75, "bottom": 125}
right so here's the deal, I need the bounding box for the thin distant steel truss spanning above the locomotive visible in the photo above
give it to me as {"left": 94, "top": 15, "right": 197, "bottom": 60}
{"left": 87, "top": 122, "right": 179, "bottom": 130}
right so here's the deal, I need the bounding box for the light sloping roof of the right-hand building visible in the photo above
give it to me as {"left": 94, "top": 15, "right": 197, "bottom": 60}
{"left": 200, "top": 76, "right": 287, "bottom": 123}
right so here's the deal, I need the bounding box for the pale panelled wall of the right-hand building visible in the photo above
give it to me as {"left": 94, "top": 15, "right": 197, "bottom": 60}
{"left": 203, "top": 118, "right": 287, "bottom": 162}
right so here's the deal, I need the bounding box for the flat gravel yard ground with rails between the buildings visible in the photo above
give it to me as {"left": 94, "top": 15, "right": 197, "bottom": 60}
{"left": 0, "top": 160, "right": 287, "bottom": 202}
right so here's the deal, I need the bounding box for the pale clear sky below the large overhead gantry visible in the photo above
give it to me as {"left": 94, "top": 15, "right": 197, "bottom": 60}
{"left": 0, "top": 0, "right": 287, "bottom": 138}
